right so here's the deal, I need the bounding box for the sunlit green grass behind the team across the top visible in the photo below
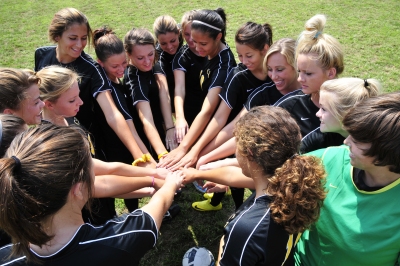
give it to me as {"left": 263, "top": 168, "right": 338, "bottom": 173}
{"left": 0, "top": 0, "right": 400, "bottom": 91}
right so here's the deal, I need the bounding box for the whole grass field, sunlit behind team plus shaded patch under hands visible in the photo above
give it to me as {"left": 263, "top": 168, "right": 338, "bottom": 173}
{"left": 0, "top": 0, "right": 400, "bottom": 266}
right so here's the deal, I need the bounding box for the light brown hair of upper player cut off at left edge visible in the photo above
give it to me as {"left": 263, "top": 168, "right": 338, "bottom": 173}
{"left": 0, "top": 68, "right": 39, "bottom": 112}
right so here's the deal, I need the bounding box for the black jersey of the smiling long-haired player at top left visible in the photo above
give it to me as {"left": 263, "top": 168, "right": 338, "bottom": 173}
{"left": 35, "top": 46, "right": 111, "bottom": 154}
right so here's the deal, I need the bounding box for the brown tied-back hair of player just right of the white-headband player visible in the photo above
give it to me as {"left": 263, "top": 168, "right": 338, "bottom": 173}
{"left": 235, "top": 22, "right": 272, "bottom": 51}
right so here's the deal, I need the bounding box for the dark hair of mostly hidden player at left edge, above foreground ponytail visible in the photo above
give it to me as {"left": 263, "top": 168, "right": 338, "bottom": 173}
{"left": 0, "top": 114, "right": 28, "bottom": 158}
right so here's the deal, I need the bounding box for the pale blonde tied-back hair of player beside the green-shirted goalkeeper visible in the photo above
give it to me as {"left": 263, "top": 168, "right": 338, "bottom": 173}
{"left": 320, "top": 78, "right": 382, "bottom": 121}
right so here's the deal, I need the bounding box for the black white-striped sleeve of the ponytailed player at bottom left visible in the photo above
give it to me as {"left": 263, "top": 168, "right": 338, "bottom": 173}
{"left": 109, "top": 209, "right": 158, "bottom": 257}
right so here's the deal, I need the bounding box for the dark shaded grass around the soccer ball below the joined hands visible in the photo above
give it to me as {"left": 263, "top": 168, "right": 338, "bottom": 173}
{"left": 140, "top": 185, "right": 241, "bottom": 266}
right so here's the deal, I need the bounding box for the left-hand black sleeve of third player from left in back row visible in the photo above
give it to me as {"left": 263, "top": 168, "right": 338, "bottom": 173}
{"left": 124, "top": 68, "right": 150, "bottom": 106}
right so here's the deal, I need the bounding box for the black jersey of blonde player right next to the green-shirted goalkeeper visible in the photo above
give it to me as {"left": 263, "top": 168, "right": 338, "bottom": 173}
{"left": 300, "top": 127, "right": 345, "bottom": 154}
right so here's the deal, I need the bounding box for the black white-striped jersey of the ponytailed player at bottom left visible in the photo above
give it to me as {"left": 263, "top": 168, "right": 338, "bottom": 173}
{"left": 0, "top": 210, "right": 158, "bottom": 266}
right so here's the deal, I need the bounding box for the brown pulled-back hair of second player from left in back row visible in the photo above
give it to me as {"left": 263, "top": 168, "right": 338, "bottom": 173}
{"left": 93, "top": 26, "right": 124, "bottom": 62}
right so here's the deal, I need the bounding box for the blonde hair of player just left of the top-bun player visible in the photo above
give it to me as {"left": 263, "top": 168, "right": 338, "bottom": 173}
{"left": 263, "top": 38, "right": 296, "bottom": 72}
